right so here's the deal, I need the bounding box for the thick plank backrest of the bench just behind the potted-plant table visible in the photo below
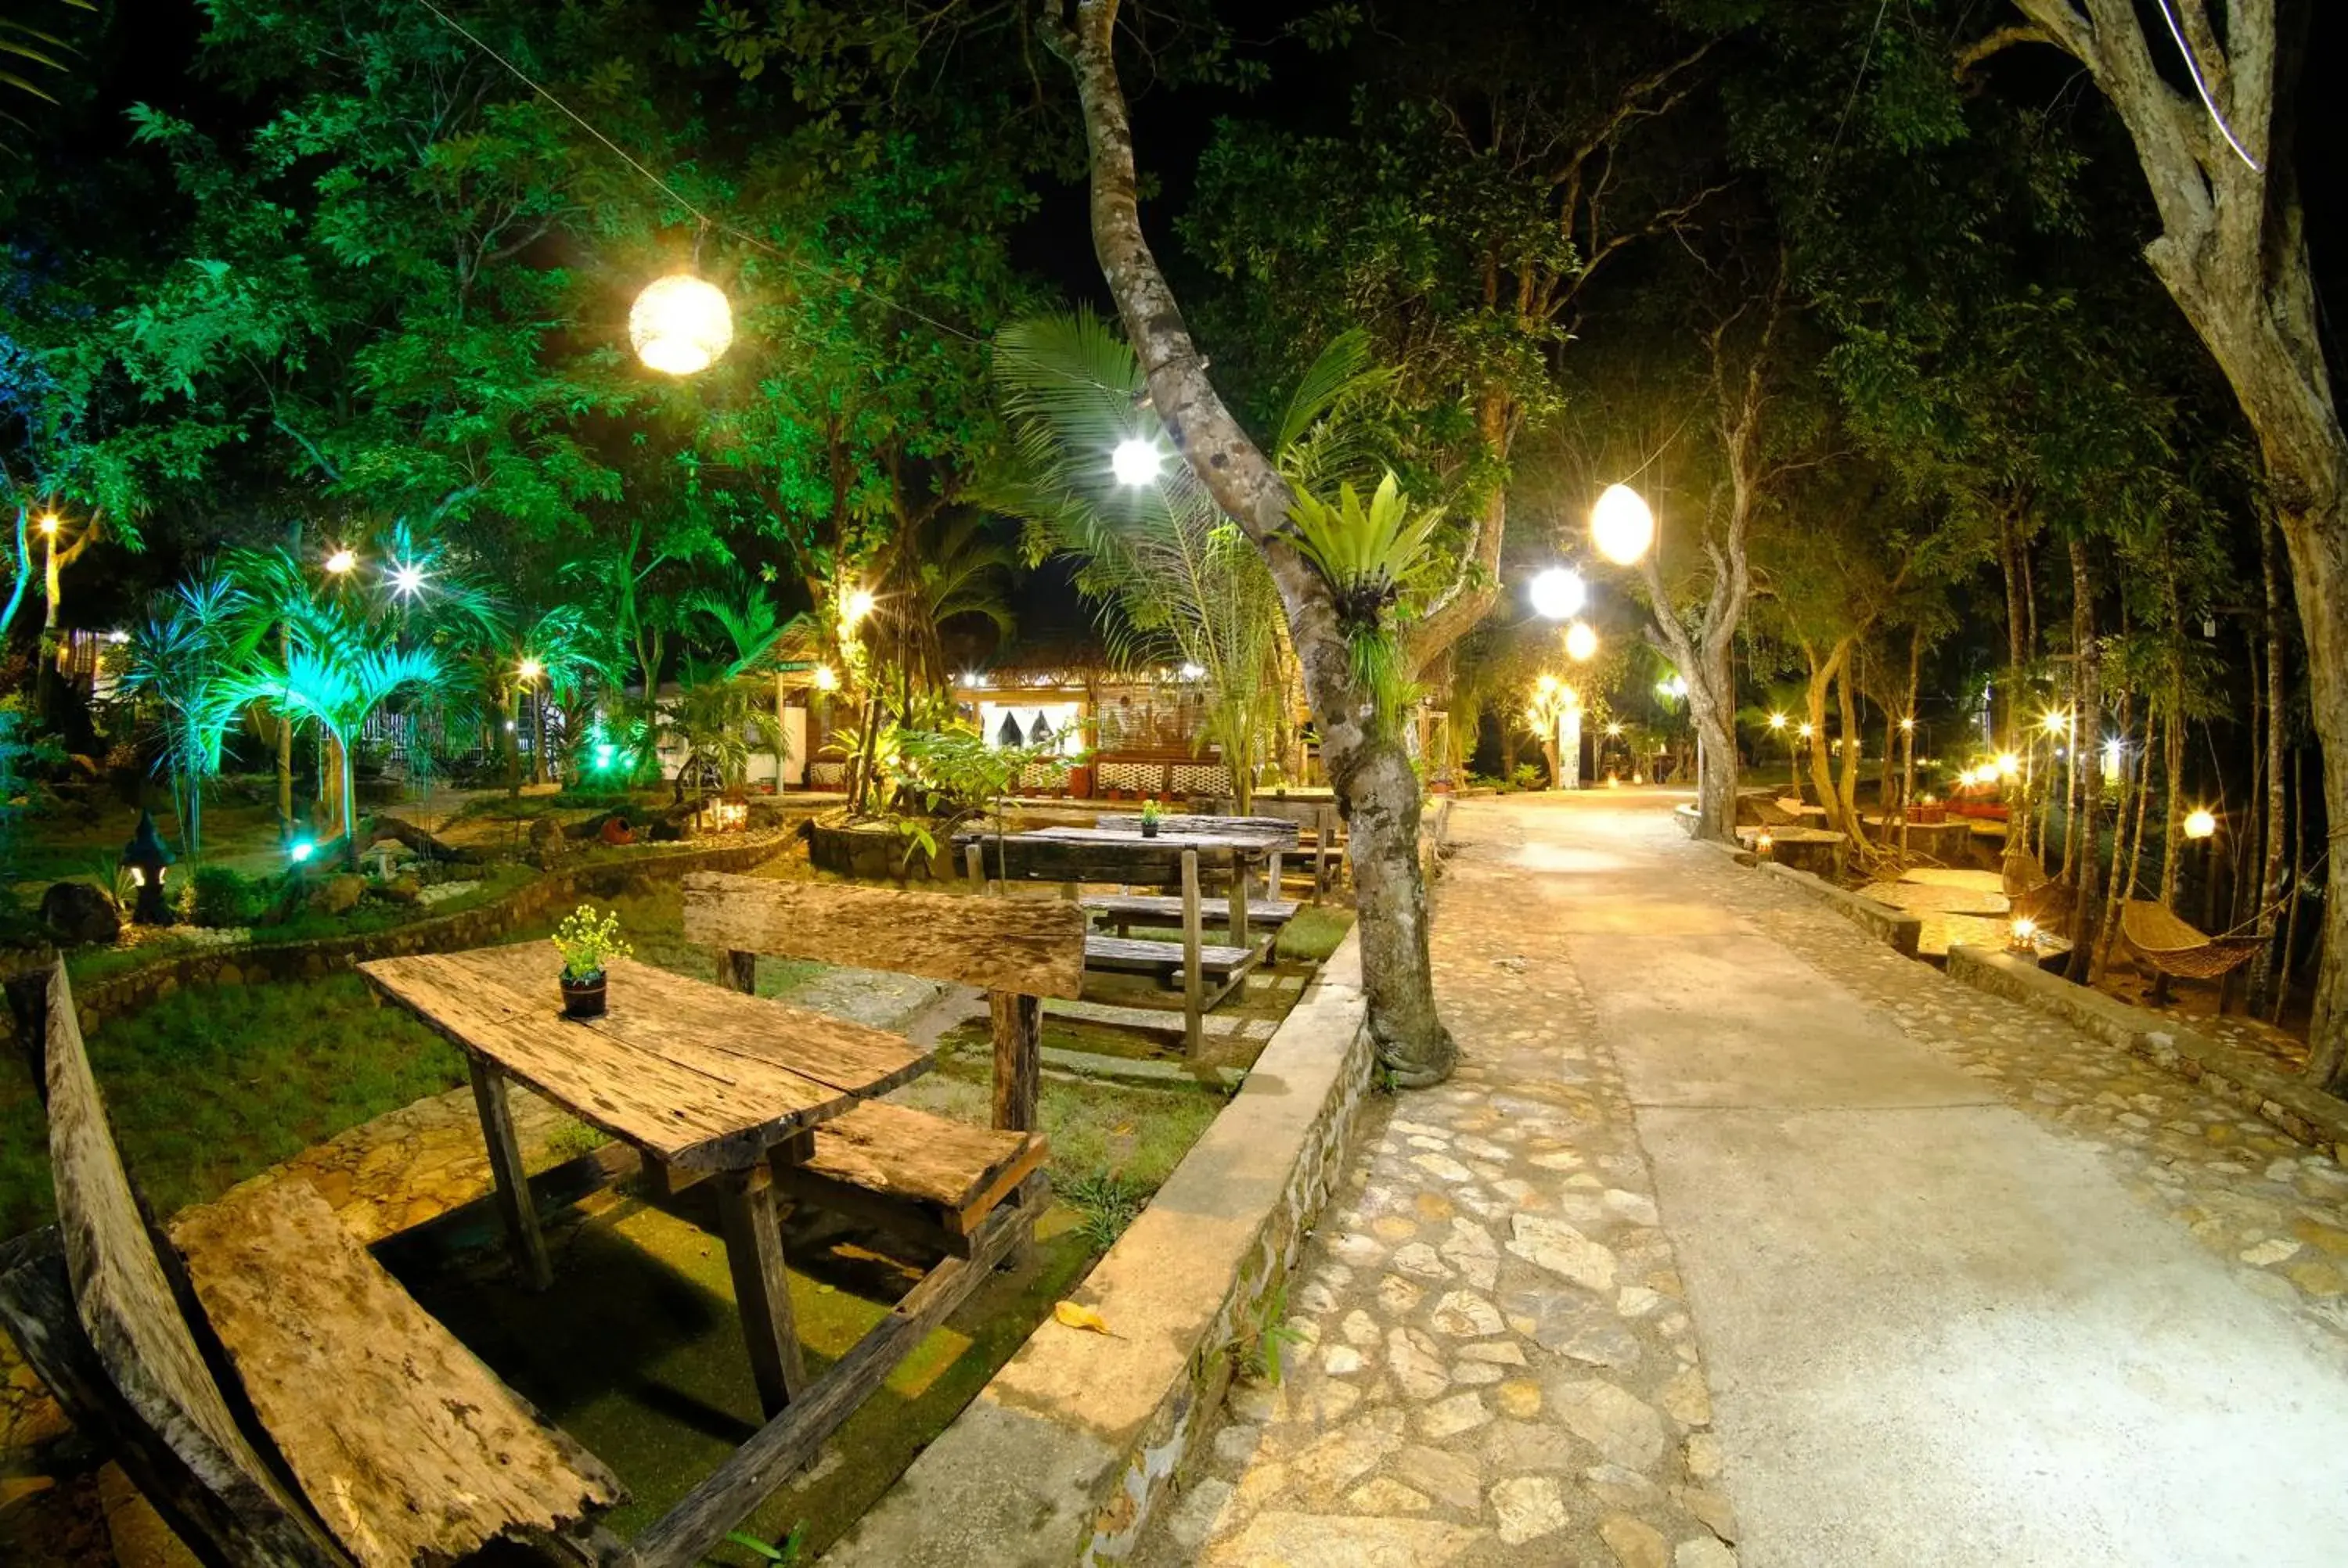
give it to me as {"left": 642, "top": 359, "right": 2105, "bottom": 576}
{"left": 683, "top": 871, "right": 1085, "bottom": 998}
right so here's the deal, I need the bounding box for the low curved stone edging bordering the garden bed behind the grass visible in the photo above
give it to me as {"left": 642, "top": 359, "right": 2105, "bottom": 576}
{"left": 52, "top": 833, "right": 787, "bottom": 1033}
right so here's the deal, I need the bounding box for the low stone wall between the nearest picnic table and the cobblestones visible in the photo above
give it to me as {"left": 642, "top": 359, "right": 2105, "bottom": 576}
{"left": 824, "top": 937, "right": 1371, "bottom": 1568}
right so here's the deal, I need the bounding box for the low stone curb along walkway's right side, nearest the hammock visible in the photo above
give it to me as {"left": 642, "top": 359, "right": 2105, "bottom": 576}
{"left": 1949, "top": 944, "right": 2348, "bottom": 1164}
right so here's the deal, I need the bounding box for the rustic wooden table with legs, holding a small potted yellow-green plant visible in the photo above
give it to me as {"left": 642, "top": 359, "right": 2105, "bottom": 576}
{"left": 359, "top": 941, "right": 935, "bottom": 1415}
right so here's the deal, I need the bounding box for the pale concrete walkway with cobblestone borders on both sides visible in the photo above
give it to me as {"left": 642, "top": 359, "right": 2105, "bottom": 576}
{"left": 1151, "top": 796, "right": 2348, "bottom": 1568}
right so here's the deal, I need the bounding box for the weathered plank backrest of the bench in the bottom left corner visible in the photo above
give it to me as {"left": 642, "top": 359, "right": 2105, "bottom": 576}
{"left": 9, "top": 962, "right": 345, "bottom": 1568}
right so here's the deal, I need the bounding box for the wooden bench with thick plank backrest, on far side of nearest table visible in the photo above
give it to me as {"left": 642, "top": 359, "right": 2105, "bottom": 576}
{"left": 683, "top": 871, "right": 1085, "bottom": 1256}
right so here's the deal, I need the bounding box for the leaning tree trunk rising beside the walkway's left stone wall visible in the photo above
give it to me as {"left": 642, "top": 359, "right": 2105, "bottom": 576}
{"left": 1043, "top": 0, "right": 1458, "bottom": 1087}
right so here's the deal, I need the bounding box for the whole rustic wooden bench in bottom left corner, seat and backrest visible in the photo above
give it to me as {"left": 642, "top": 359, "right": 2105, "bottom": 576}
{"left": 0, "top": 965, "right": 625, "bottom": 1568}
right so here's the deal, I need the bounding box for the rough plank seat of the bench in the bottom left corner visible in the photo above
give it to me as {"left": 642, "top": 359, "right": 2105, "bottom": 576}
{"left": 171, "top": 1176, "right": 622, "bottom": 1568}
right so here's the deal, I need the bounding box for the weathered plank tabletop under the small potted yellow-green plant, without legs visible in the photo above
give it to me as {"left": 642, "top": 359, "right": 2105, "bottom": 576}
{"left": 359, "top": 941, "right": 932, "bottom": 1171}
